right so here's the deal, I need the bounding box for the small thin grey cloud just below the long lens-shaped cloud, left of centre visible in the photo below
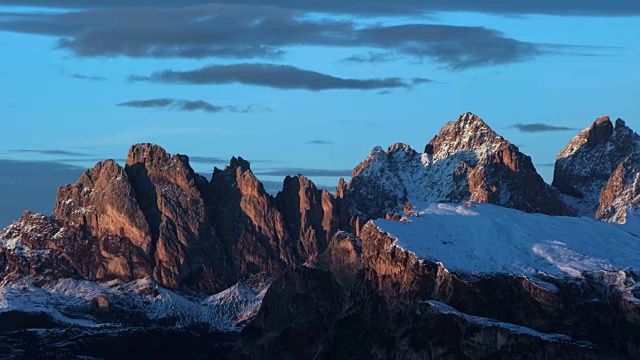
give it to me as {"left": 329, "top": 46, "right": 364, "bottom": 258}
{"left": 117, "top": 98, "right": 271, "bottom": 113}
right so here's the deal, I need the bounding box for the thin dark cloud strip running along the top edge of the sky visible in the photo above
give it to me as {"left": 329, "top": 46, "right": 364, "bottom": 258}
{"left": 0, "top": 0, "right": 640, "bottom": 16}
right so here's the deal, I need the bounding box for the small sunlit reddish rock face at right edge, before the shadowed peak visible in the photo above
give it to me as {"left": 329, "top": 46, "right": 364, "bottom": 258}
{"left": 596, "top": 153, "right": 640, "bottom": 224}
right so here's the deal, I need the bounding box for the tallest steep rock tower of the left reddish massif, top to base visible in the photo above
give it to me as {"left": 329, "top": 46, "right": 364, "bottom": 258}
{"left": 126, "top": 144, "right": 236, "bottom": 293}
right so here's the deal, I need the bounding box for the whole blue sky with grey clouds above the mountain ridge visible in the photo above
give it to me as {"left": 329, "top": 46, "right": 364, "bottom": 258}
{"left": 0, "top": 0, "right": 640, "bottom": 225}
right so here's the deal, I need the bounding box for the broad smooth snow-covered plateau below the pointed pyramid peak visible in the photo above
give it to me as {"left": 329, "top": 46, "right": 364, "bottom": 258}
{"left": 374, "top": 204, "right": 640, "bottom": 282}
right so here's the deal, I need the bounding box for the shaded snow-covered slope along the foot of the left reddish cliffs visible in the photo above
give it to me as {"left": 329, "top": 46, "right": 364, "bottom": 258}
{"left": 0, "top": 276, "right": 271, "bottom": 331}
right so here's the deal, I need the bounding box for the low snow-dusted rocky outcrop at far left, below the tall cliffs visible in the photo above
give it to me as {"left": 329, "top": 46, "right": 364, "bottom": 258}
{"left": 0, "top": 211, "right": 153, "bottom": 281}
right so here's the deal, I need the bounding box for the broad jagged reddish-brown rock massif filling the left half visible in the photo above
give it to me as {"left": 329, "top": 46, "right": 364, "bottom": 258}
{"left": 0, "top": 144, "right": 338, "bottom": 294}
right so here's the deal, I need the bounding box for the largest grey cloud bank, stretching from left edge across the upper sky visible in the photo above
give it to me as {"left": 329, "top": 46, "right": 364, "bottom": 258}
{"left": 0, "top": 4, "right": 562, "bottom": 70}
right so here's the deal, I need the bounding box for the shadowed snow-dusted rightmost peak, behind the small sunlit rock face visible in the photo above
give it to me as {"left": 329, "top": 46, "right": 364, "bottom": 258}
{"left": 553, "top": 116, "right": 640, "bottom": 217}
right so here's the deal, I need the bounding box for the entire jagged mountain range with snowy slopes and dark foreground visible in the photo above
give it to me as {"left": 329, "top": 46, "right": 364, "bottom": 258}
{"left": 0, "top": 113, "right": 640, "bottom": 359}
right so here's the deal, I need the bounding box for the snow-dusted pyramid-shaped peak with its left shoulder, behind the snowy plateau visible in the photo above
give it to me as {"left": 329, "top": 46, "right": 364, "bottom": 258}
{"left": 337, "top": 113, "right": 573, "bottom": 223}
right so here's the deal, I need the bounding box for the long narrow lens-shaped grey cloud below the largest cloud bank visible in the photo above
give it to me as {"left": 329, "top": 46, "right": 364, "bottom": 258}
{"left": 130, "top": 64, "right": 426, "bottom": 91}
